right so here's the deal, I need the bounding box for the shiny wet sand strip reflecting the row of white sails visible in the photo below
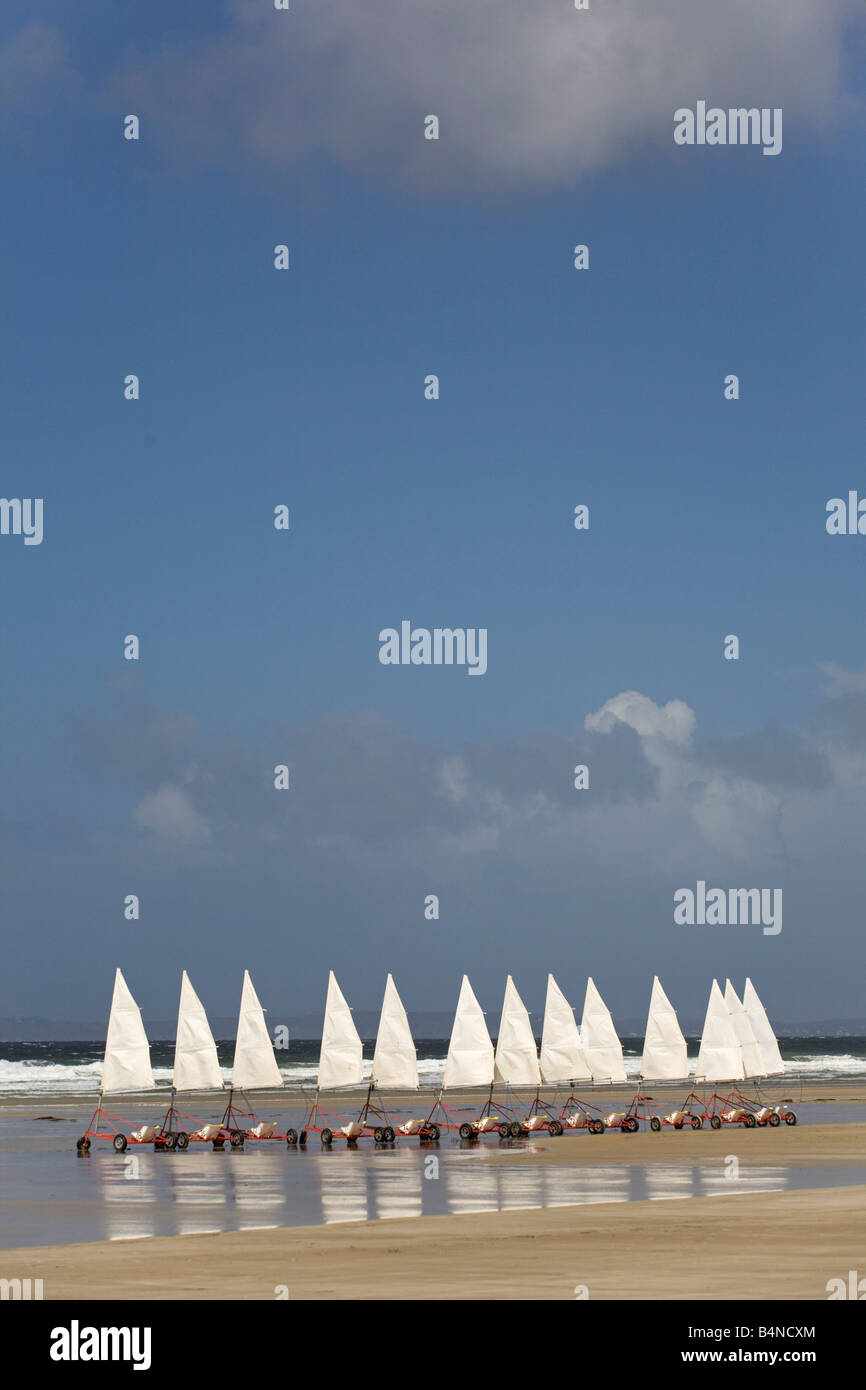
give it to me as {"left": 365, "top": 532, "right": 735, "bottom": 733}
{"left": 0, "top": 1143, "right": 863, "bottom": 1245}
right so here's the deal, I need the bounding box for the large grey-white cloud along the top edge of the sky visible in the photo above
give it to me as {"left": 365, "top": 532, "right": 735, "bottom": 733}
{"left": 117, "top": 0, "right": 859, "bottom": 190}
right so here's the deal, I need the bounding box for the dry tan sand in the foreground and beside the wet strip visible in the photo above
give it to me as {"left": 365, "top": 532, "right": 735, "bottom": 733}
{"left": 1, "top": 1125, "right": 866, "bottom": 1300}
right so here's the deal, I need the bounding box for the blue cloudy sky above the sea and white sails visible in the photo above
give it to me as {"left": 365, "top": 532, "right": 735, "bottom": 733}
{"left": 0, "top": 0, "right": 866, "bottom": 1022}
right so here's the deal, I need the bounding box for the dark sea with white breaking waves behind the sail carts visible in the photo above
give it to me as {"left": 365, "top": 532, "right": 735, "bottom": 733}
{"left": 0, "top": 1036, "right": 866, "bottom": 1098}
